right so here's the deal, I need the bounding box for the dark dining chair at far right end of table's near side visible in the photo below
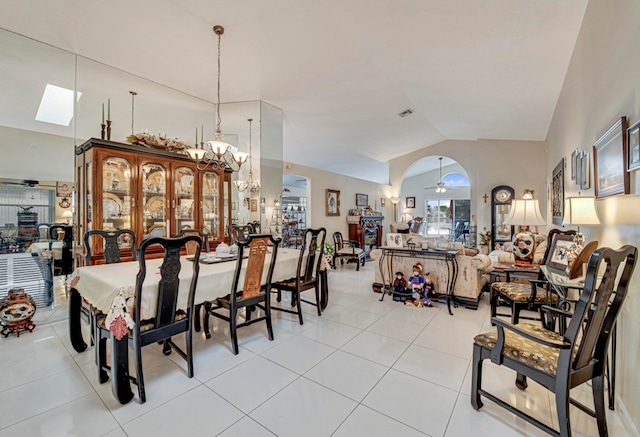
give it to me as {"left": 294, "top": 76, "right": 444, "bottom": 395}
{"left": 272, "top": 228, "right": 327, "bottom": 325}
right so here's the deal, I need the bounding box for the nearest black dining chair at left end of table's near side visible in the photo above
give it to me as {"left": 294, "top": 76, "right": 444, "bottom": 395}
{"left": 97, "top": 235, "right": 202, "bottom": 403}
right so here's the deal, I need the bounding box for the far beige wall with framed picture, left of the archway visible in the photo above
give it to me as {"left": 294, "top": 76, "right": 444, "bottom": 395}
{"left": 284, "top": 164, "right": 393, "bottom": 241}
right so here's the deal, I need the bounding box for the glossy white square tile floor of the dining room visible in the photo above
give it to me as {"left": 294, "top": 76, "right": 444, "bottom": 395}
{"left": 0, "top": 263, "right": 630, "bottom": 437}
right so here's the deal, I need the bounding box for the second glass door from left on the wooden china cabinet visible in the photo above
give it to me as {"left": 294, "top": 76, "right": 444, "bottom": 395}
{"left": 141, "top": 163, "right": 168, "bottom": 238}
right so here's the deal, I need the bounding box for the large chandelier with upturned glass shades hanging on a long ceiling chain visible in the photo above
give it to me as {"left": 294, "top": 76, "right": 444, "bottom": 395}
{"left": 187, "top": 25, "right": 249, "bottom": 171}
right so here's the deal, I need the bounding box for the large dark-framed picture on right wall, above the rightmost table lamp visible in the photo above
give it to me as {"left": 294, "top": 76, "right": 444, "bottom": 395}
{"left": 593, "top": 117, "right": 630, "bottom": 199}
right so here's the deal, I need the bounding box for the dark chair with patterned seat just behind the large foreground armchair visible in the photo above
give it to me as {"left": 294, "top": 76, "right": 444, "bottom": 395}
{"left": 490, "top": 229, "right": 576, "bottom": 325}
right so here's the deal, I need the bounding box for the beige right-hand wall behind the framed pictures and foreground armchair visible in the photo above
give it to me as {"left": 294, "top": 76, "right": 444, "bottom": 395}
{"left": 546, "top": 0, "right": 640, "bottom": 428}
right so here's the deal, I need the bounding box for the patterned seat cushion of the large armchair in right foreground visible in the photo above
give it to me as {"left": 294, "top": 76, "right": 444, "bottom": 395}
{"left": 473, "top": 323, "right": 562, "bottom": 375}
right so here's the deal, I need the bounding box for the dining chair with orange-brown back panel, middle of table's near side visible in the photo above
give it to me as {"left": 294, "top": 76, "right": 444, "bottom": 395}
{"left": 204, "top": 234, "right": 280, "bottom": 355}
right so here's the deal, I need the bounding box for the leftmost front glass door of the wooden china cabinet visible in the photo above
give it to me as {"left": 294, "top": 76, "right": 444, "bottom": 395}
{"left": 102, "top": 158, "right": 132, "bottom": 231}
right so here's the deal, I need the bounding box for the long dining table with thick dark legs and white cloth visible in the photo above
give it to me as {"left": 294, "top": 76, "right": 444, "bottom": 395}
{"left": 69, "top": 248, "right": 328, "bottom": 404}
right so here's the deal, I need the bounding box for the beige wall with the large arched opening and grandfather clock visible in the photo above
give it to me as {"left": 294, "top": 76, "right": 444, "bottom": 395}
{"left": 389, "top": 140, "right": 551, "bottom": 237}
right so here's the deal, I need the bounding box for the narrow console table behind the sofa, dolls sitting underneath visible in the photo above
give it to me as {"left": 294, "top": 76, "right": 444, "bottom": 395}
{"left": 379, "top": 247, "right": 458, "bottom": 315}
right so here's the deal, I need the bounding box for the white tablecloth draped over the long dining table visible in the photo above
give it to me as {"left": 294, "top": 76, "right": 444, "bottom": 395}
{"left": 73, "top": 248, "right": 300, "bottom": 319}
